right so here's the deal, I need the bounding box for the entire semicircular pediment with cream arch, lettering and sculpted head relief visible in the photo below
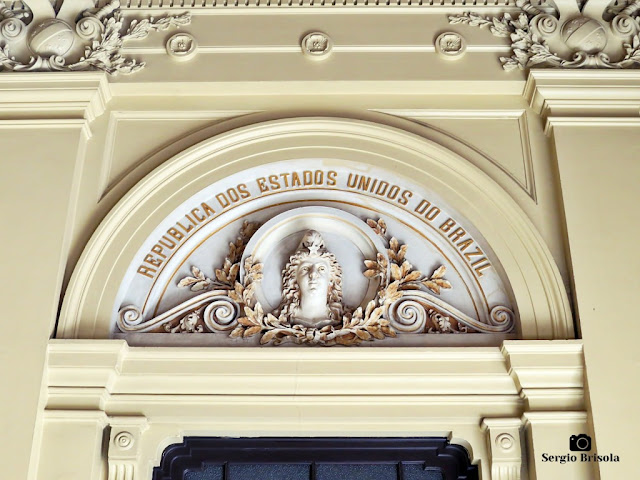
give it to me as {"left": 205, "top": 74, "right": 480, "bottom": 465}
{"left": 58, "top": 118, "right": 572, "bottom": 346}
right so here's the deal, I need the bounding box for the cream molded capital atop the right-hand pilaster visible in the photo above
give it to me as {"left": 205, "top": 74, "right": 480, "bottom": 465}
{"left": 523, "top": 69, "right": 640, "bottom": 134}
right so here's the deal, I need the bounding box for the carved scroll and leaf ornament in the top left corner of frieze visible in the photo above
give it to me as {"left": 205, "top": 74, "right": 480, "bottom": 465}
{"left": 0, "top": 0, "right": 190, "bottom": 75}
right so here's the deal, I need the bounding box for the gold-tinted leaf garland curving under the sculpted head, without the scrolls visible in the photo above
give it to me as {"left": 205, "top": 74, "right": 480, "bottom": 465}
{"left": 151, "top": 219, "right": 504, "bottom": 346}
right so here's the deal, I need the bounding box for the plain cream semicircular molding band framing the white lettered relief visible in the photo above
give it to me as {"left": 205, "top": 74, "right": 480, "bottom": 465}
{"left": 57, "top": 118, "right": 573, "bottom": 339}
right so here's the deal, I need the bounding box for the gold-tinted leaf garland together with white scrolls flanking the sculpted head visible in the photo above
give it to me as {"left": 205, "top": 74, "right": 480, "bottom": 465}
{"left": 118, "top": 219, "right": 514, "bottom": 346}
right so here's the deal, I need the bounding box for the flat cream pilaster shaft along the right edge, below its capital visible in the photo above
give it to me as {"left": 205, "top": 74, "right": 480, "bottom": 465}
{"left": 552, "top": 122, "right": 640, "bottom": 479}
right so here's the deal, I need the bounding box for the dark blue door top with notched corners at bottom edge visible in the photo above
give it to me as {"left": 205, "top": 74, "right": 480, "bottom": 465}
{"left": 153, "top": 437, "right": 479, "bottom": 480}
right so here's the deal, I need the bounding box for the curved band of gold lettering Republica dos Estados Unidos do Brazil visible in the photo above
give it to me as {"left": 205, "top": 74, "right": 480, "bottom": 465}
{"left": 137, "top": 169, "right": 491, "bottom": 279}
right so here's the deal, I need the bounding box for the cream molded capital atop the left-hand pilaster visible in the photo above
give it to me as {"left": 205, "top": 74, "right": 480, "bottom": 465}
{"left": 0, "top": 72, "right": 111, "bottom": 123}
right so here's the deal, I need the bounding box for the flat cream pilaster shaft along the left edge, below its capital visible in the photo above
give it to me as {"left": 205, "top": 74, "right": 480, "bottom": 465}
{"left": 0, "top": 124, "right": 86, "bottom": 480}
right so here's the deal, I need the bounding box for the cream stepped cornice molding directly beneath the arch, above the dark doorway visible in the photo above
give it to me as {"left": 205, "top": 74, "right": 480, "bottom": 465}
{"left": 47, "top": 340, "right": 584, "bottom": 410}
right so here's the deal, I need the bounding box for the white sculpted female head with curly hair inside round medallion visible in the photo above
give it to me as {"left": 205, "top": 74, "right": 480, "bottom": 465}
{"left": 280, "top": 230, "right": 342, "bottom": 328}
